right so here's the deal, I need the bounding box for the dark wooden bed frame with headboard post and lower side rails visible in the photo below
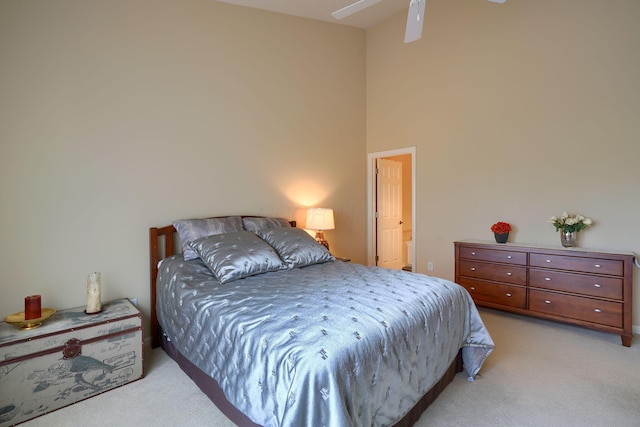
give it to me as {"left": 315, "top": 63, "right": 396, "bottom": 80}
{"left": 149, "top": 221, "right": 463, "bottom": 427}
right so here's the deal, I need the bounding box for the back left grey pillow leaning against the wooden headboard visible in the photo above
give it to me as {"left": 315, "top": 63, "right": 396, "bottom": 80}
{"left": 173, "top": 216, "right": 242, "bottom": 261}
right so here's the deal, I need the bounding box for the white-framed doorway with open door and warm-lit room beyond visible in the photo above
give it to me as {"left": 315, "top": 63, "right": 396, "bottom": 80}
{"left": 367, "top": 147, "right": 416, "bottom": 271}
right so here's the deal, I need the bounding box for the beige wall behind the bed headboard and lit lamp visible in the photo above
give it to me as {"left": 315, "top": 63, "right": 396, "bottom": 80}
{"left": 0, "top": 0, "right": 366, "bottom": 334}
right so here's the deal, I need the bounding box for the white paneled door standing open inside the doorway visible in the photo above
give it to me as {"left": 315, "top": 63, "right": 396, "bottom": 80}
{"left": 376, "top": 158, "right": 403, "bottom": 270}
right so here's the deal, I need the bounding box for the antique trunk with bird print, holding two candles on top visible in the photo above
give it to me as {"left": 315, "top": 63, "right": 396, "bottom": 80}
{"left": 0, "top": 299, "right": 143, "bottom": 427}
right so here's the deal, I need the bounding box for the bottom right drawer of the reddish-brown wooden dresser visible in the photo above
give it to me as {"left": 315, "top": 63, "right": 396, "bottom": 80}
{"left": 529, "top": 289, "right": 622, "bottom": 328}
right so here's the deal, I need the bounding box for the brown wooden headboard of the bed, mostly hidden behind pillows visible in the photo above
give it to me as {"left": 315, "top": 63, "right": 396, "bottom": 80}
{"left": 149, "top": 219, "right": 296, "bottom": 348}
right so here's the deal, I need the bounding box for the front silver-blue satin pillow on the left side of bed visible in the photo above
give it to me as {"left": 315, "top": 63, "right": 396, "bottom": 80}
{"left": 189, "top": 231, "right": 285, "bottom": 283}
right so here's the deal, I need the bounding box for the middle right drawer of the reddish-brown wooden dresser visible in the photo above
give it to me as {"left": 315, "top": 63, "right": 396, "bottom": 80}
{"left": 529, "top": 268, "right": 623, "bottom": 301}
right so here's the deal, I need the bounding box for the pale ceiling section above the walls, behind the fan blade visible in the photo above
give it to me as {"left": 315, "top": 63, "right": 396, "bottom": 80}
{"left": 218, "top": 0, "right": 409, "bottom": 29}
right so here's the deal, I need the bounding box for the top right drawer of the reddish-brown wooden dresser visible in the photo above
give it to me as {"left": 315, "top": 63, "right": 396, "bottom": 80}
{"left": 529, "top": 253, "right": 624, "bottom": 276}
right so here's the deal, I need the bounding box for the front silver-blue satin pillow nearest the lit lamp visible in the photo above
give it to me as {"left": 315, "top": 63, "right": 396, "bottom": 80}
{"left": 257, "top": 227, "right": 335, "bottom": 268}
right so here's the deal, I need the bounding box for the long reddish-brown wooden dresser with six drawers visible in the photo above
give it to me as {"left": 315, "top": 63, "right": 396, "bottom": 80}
{"left": 454, "top": 240, "right": 634, "bottom": 347}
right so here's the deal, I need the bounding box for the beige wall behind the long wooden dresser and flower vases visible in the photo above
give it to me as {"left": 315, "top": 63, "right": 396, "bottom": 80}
{"left": 367, "top": 0, "right": 640, "bottom": 329}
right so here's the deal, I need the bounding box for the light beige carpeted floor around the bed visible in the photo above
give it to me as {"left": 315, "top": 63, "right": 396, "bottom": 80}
{"left": 23, "top": 309, "right": 640, "bottom": 427}
